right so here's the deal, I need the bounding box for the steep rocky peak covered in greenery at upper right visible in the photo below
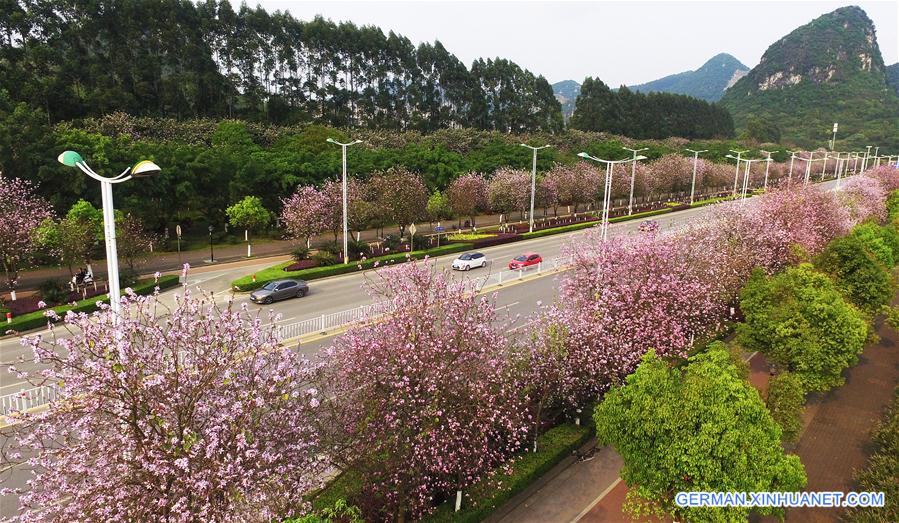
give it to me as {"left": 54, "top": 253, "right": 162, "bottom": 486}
{"left": 720, "top": 6, "right": 899, "bottom": 149}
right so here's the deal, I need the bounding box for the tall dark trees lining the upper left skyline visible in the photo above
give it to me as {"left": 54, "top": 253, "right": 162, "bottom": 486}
{"left": 0, "top": 0, "right": 562, "bottom": 132}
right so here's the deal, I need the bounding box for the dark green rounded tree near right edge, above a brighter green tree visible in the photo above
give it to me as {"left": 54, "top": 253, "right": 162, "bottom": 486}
{"left": 815, "top": 235, "right": 894, "bottom": 313}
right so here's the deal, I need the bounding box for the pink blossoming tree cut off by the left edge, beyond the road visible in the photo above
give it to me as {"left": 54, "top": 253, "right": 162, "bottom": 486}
{"left": 0, "top": 175, "right": 53, "bottom": 297}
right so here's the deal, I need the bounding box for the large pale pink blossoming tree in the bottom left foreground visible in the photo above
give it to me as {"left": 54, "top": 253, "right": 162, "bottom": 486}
{"left": 2, "top": 292, "right": 324, "bottom": 522}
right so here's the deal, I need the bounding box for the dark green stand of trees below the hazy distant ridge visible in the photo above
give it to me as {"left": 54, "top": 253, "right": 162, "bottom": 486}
{"left": 569, "top": 76, "right": 736, "bottom": 141}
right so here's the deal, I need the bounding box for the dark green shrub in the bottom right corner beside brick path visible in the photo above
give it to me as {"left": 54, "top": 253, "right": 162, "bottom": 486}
{"left": 846, "top": 387, "right": 899, "bottom": 523}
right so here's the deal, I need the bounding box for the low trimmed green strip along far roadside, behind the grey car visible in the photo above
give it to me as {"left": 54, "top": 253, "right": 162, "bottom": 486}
{"left": 231, "top": 243, "right": 472, "bottom": 291}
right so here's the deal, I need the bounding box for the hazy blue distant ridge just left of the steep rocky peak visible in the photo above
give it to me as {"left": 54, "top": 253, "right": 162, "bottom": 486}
{"left": 628, "top": 53, "right": 749, "bottom": 102}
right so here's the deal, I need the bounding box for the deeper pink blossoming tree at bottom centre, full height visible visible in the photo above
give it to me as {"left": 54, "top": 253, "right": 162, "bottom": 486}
{"left": 317, "top": 262, "right": 527, "bottom": 521}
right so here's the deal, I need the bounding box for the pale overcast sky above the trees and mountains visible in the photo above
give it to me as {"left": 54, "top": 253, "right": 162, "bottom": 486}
{"left": 255, "top": 0, "right": 899, "bottom": 86}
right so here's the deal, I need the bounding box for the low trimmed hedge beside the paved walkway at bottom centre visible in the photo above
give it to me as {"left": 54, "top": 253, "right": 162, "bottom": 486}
{"left": 422, "top": 424, "right": 592, "bottom": 523}
